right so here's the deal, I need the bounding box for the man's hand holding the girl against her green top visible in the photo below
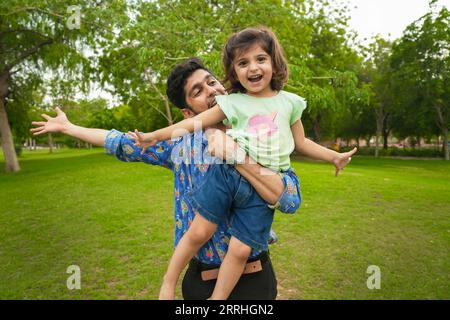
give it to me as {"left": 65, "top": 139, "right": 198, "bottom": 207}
{"left": 206, "top": 129, "right": 245, "bottom": 163}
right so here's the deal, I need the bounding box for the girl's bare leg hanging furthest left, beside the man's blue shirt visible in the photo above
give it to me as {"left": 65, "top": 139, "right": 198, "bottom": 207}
{"left": 159, "top": 214, "right": 217, "bottom": 300}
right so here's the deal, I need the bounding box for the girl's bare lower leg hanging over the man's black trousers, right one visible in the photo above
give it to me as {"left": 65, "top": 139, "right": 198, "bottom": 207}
{"left": 210, "top": 237, "right": 252, "bottom": 300}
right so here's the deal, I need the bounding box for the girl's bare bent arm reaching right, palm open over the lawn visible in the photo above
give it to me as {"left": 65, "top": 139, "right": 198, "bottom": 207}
{"left": 291, "top": 120, "right": 357, "bottom": 176}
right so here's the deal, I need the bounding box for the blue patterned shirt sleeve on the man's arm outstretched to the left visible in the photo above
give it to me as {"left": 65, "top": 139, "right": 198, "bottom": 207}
{"left": 105, "top": 129, "right": 174, "bottom": 169}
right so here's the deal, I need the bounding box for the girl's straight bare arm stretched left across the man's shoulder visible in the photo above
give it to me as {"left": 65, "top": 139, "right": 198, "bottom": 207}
{"left": 129, "top": 105, "right": 226, "bottom": 146}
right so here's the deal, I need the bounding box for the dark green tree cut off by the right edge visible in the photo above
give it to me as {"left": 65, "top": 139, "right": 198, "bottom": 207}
{"left": 391, "top": 8, "right": 450, "bottom": 160}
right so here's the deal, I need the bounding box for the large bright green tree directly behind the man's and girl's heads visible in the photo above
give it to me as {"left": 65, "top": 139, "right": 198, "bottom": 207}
{"left": 100, "top": 0, "right": 314, "bottom": 130}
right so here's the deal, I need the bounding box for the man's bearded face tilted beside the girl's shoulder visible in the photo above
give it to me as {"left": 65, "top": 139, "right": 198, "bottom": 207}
{"left": 182, "top": 69, "right": 226, "bottom": 118}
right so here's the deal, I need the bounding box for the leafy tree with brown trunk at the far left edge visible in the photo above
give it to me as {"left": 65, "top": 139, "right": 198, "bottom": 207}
{"left": 0, "top": 0, "right": 126, "bottom": 172}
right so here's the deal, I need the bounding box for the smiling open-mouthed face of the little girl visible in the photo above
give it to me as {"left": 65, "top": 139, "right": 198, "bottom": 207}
{"left": 233, "top": 44, "right": 276, "bottom": 97}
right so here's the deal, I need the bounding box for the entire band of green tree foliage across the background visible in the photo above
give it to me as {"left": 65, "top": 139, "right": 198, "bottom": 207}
{"left": 0, "top": 0, "right": 450, "bottom": 149}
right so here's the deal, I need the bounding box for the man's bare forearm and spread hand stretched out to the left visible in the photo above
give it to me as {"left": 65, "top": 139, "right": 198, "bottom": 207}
{"left": 30, "top": 107, "right": 109, "bottom": 147}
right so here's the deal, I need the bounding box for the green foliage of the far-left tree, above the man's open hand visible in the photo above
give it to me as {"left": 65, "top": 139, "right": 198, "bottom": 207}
{"left": 0, "top": 0, "right": 128, "bottom": 150}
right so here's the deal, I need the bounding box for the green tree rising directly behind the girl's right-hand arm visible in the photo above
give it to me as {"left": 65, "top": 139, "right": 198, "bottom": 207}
{"left": 289, "top": 0, "right": 360, "bottom": 142}
